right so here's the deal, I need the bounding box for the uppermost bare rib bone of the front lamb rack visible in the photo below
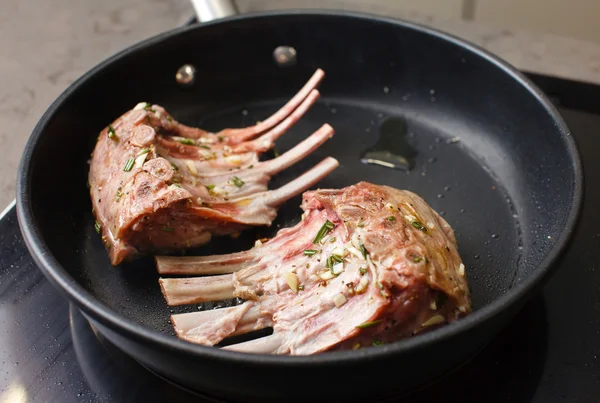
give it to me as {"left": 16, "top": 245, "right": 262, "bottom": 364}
{"left": 156, "top": 249, "right": 255, "bottom": 275}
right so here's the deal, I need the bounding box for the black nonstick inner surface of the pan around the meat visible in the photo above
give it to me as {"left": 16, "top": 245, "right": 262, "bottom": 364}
{"left": 19, "top": 15, "right": 579, "bottom": 356}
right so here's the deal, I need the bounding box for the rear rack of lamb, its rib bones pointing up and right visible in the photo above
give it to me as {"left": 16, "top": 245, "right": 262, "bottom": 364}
{"left": 89, "top": 69, "right": 338, "bottom": 265}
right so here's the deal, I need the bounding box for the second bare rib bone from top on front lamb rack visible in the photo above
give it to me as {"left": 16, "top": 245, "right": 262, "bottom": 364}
{"left": 158, "top": 274, "right": 233, "bottom": 306}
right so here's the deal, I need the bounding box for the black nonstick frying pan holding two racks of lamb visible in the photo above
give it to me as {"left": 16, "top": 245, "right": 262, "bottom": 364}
{"left": 17, "top": 3, "right": 583, "bottom": 402}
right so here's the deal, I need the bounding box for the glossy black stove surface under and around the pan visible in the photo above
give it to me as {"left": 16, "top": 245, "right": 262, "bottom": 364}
{"left": 0, "top": 75, "right": 600, "bottom": 403}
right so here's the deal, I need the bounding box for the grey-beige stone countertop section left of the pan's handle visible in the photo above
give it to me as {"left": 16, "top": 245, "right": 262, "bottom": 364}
{"left": 0, "top": 0, "right": 192, "bottom": 210}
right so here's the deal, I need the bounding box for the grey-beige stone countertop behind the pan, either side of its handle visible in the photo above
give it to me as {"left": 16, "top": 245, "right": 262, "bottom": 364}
{"left": 0, "top": 0, "right": 600, "bottom": 210}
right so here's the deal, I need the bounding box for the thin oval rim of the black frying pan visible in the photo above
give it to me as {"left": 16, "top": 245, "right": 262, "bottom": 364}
{"left": 17, "top": 9, "right": 584, "bottom": 367}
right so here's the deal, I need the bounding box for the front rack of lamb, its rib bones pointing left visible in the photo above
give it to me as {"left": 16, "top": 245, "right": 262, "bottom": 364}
{"left": 156, "top": 182, "right": 471, "bottom": 355}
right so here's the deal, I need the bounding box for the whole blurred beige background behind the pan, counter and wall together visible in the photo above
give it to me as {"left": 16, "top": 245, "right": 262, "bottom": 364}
{"left": 0, "top": 0, "right": 600, "bottom": 210}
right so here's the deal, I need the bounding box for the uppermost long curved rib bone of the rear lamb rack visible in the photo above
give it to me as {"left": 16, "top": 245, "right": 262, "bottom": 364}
{"left": 219, "top": 69, "right": 325, "bottom": 142}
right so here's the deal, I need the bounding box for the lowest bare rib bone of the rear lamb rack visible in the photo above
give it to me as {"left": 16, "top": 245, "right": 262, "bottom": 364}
{"left": 259, "top": 157, "right": 340, "bottom": 207}
